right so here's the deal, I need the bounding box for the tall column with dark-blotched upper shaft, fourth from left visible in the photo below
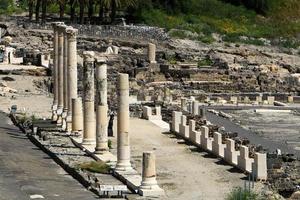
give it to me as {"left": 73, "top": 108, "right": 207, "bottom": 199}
{"left": 82, "top": 51, "right": 96, "bottom": 145}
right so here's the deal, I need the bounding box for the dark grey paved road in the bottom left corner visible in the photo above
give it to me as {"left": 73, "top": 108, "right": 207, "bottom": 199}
{"left": 0, "top": 113, "right": 97, "bottom": 200}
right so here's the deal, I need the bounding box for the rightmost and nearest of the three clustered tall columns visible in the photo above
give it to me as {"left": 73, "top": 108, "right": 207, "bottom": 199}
{"left": 66, "top": 28, "right": 78, "bottom": 132}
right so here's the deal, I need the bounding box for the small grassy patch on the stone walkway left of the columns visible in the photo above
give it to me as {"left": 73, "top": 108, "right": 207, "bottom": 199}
{"left": 76, "top": 161, "right": 110, "bottom": 174}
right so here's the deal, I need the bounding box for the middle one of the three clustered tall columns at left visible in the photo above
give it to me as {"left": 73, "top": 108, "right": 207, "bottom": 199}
{"left": 62, "top": 26, "right": 71, "bottom": 130}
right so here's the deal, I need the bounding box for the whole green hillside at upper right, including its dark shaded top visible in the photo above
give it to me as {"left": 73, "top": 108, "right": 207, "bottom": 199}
{"left": 134, "top": 0, "right": 300, "bottom": 48}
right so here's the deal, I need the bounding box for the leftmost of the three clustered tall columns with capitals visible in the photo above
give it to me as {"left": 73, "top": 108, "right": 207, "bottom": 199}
{"left": 57, "top": 25, "right": 66, "bottom": 125}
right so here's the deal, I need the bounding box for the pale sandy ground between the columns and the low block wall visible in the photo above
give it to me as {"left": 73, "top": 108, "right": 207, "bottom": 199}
{"left": 113, "top": 118, "right": 261, "bottom": 200}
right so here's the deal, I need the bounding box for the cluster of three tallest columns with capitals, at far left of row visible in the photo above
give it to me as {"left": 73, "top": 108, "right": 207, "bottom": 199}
{"left": 52, "top": 22, "right": 78, "bottom": 131}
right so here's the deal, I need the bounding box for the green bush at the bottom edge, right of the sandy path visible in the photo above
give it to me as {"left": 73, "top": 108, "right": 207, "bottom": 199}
{"left": 226, "top": 187, "right": 259, "bottom": 200}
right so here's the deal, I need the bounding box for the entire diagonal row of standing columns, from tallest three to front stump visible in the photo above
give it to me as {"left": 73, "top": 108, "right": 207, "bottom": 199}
{"left": 52, "top": 25, "right": 161, "bottom": 194}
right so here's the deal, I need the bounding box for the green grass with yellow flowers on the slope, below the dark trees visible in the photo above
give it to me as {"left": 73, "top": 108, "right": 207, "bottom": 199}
{"left": 138, "top": 0, "right": 300, "bottom": 48}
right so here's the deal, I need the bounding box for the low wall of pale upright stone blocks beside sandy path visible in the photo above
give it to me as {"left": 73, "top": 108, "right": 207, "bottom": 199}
{"left": 170, "top": 111, "right": 267, "bottom": 180}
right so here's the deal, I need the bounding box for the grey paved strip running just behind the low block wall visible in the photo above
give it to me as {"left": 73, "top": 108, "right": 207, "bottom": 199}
{"left": 207, "top": 112, "right": 300, "bottom": 157}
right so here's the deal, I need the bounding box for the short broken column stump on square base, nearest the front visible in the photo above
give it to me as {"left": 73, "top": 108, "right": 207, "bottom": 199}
{"left": 139, "top": 152, "right": 164, "bottom": 196}
